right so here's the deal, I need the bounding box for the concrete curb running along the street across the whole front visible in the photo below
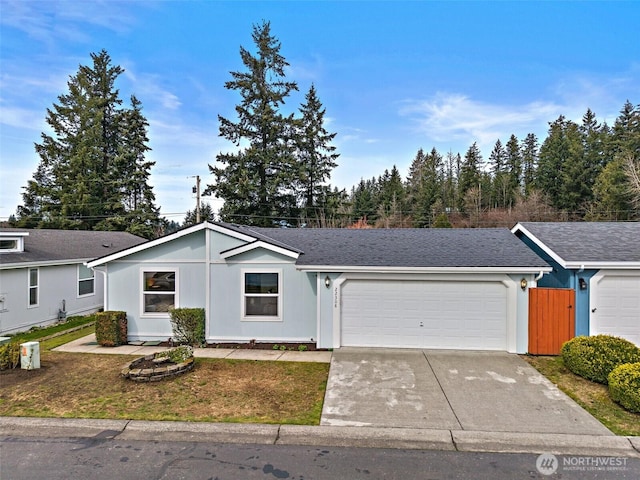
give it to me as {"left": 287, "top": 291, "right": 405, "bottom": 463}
{"left": 0, "top": 417, "right": 640, "bottom": 458}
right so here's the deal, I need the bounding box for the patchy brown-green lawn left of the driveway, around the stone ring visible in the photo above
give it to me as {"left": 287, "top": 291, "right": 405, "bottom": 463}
{"left": 0, "top": 351, "right": 329, "bottom": 425}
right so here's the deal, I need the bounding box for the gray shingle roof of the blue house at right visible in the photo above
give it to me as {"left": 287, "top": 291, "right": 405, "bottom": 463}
{"left": 520, "top": 222, "right": 640, "bottom": 262}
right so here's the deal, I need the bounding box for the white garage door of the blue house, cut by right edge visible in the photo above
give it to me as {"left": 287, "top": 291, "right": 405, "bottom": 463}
{"left": 589, "top": 273, "right": 640, "bottom": 345}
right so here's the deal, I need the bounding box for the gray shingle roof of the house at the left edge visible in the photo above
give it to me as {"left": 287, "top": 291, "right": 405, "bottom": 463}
{"left": 0, "top": 228, "right": 146, "bottom": 267}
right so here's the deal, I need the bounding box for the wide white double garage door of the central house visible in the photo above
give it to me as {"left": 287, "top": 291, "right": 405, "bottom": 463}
{"left": 341, "top": 280, "right": 507, "bottom": 350}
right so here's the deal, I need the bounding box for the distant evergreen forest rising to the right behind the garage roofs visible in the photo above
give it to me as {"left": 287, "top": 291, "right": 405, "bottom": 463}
{"left": 343, "top": 101, "right": 640, "bottom": 227}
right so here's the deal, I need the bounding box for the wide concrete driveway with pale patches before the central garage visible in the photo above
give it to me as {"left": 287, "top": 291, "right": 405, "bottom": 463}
{"left": 321, "top": 348, "right": 612, "bottom": 435}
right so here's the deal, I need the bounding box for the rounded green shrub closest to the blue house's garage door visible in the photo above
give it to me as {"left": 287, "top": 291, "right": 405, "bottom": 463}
{"left": 560, "top": 335, "right": 640, "bottom": 385}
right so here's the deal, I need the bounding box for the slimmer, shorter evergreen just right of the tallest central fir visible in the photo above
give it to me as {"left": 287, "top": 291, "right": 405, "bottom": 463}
{"left": 296, "top": 85, "right": 340, "bottom": 219}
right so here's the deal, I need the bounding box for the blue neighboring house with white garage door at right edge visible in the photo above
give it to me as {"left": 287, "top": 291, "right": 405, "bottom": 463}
{"left": 512, "top": 222, "right": 640, "bottom": 345}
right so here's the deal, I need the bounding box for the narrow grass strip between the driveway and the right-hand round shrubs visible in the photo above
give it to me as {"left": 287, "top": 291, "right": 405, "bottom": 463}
{"left": 522, "top": 355, "right": 640, "bottom": 436}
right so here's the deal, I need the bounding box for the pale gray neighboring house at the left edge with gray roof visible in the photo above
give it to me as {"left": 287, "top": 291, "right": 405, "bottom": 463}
{"left": 0, "top": 228, "right": 145, "bottom": 333}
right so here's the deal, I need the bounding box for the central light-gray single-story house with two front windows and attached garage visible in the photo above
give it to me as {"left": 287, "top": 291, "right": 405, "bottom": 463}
{"left": 87, "top": 223, "right": 551, "bottom": 353}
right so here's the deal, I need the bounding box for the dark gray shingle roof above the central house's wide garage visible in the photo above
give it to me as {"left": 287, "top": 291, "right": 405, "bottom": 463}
{"left": 223, "top": 224, "right": 548, "bottom": 267}
